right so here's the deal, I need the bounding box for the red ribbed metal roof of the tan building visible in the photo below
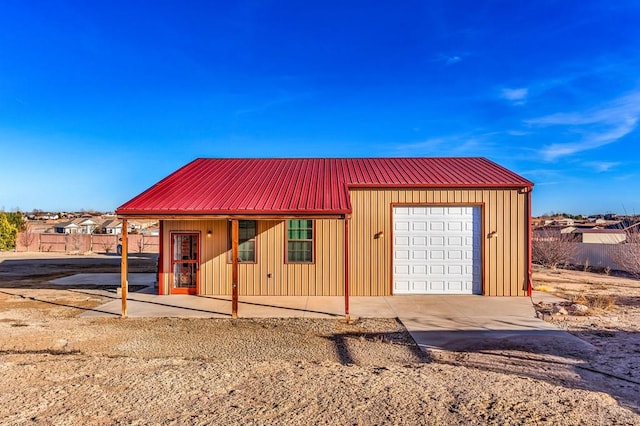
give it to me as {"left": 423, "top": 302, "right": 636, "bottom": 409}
{"left": 116, "top": 158, "right": 533, "bottom": 215}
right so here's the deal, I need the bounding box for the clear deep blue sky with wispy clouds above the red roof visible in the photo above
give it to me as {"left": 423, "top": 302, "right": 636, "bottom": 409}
{"left": 0, "top": 0, "right": 640, "bottom": 215}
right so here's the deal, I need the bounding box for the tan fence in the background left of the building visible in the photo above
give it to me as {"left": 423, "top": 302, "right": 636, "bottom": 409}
{"left": 16, "top": 232, "right": 159, "bottom": 254}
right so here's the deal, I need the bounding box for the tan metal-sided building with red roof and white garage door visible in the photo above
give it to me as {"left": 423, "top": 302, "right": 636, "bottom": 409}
{"left": 116, "top": 158, "right": 533, "bottom": 296}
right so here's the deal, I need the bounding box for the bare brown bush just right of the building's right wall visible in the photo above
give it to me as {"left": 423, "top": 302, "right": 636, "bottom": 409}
{"left": 532, "top": 229, "right": 578, "bottom": 269}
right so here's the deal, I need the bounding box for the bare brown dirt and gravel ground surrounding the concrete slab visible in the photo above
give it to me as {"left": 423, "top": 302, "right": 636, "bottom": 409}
{"left": 0, "top": 253, "right": 640, "bottom": 425}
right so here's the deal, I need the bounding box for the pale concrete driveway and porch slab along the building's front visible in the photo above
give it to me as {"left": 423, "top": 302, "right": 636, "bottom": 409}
{"left": 53, "top": 274, "right": 593, "bottom": 351}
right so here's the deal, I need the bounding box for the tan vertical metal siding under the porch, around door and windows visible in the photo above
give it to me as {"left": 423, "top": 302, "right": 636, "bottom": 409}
{"left": 162, "top": 219, "right": 344, "bottom": 296}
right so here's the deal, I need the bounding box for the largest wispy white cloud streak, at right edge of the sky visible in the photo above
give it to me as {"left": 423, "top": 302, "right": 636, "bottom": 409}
{"left": 525, "top": 92, "right": 640, "bottom": 161}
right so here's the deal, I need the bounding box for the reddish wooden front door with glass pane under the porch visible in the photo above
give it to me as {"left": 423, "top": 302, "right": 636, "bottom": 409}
{"left": 170, "top": 232, "right": 200, "bottom": 294}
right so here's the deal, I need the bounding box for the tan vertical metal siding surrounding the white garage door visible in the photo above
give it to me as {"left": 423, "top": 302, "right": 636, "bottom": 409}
{"left": 349, "top": 188, "right": 527, "bottom": 296}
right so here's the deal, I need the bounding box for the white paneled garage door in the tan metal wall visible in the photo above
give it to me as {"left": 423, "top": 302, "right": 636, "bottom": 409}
{"left": 393, "top": 207, "right": 482, "bottom": 294}
